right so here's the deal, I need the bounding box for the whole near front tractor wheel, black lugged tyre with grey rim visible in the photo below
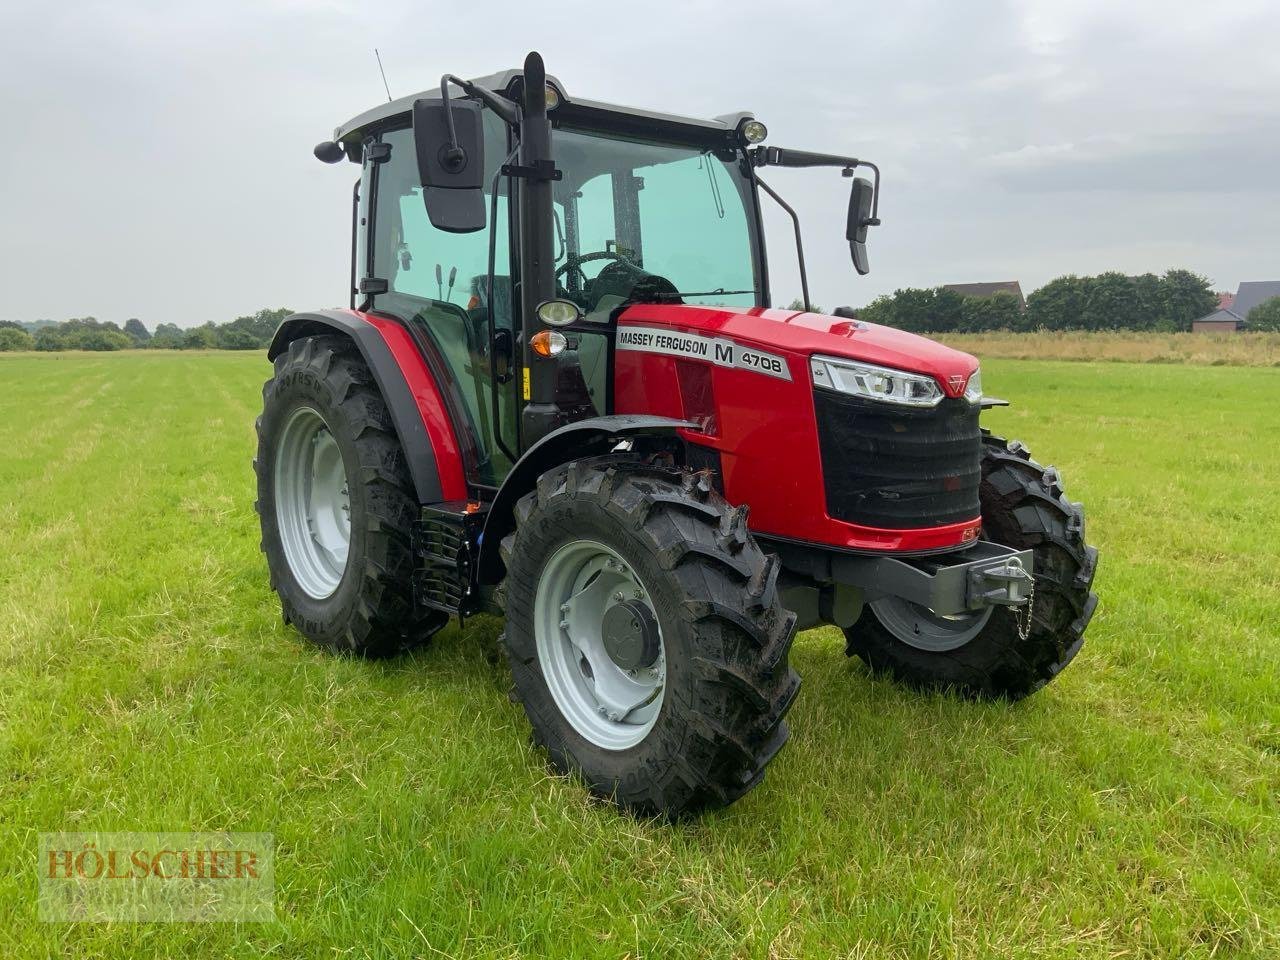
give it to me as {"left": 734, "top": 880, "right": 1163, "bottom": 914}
{"left": 502, "top": 454, "right": 800, "bottom": 818}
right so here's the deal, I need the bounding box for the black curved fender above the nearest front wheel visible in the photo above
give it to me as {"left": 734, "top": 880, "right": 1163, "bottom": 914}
{"left": 476, "top": 413, "right": 699, "bottom": 584}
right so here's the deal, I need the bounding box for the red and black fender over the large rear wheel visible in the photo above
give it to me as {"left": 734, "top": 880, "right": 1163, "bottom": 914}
{"left": 266, "top": 310, "right": 466, "bottom": 503}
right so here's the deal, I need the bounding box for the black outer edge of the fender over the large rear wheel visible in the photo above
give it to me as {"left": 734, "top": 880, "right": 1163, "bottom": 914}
{"left": 266, "top": 310, "right": 453, "bottom": 503}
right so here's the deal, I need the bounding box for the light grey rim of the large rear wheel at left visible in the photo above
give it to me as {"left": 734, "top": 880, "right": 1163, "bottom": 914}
{"left": 275, "top": 407, "right": 351, "bottom": 600}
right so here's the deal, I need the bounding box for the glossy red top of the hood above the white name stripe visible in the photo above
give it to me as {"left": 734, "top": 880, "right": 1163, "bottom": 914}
{"left": 618, "top": 303, "right": 978, "bottom": 397}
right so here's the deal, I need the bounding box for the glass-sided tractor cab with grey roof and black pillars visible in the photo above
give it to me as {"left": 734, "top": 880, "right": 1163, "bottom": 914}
{"left": 316, "top": 62, "right": 878, "bottom": 493}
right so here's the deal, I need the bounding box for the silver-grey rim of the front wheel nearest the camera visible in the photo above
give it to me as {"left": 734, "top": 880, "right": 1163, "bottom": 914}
{"left": 534, "top": 540, "right": 667, "bottom": 750}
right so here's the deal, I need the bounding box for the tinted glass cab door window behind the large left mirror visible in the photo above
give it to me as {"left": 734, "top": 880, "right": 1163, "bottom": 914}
{"left": 372, "top": 113, "right": 516, "bottom": 485}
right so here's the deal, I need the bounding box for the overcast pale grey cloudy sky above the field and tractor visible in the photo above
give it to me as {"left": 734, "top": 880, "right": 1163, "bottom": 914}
{"left": 0, "top": 0, "right": 1280, "bottom": 328}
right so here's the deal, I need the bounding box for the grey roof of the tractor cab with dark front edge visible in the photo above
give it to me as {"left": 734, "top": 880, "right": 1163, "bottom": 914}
{"left": 333, "top": 70, "right": 754, "bottom": 156}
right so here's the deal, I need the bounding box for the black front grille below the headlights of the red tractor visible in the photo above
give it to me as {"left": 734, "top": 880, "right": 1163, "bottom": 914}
{"left": 814, "top": 390, "right": 982, "bottom": 530}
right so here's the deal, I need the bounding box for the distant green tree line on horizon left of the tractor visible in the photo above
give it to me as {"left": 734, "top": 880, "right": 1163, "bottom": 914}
{"left": 0, "top": 307, "right": 293, "bottom": 351}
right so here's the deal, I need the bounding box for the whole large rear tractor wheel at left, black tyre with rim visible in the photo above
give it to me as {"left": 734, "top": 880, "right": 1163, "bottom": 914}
{"left": 253, "top": 335, "right": 448, "bottom": 657}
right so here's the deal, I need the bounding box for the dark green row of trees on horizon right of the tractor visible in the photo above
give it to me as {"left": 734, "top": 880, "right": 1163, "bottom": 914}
{"left": 858, "top": 270, "right": 1264, "bottom": 333}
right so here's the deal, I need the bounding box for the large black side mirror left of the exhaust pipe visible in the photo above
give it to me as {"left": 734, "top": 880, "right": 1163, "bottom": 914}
{"left": 413, "top": 99, "right": 485, "bottom": 233}
